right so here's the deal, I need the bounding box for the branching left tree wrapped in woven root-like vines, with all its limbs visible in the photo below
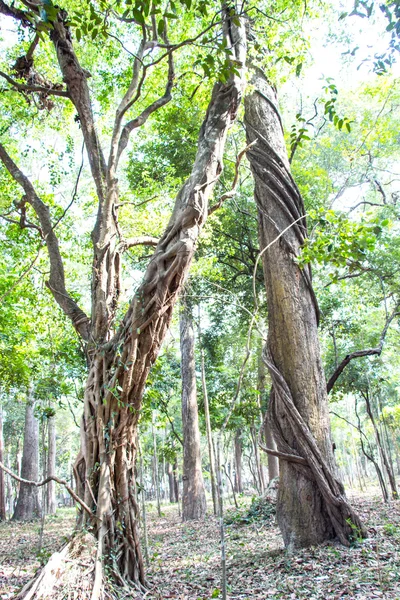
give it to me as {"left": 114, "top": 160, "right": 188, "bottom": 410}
{"left": 0, "top": 2, "right": 246, "bottom": 598}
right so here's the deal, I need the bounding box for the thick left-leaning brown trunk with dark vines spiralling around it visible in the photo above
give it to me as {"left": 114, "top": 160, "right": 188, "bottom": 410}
{"left": 245, "top": 71, "right": 361, "bottom": 548}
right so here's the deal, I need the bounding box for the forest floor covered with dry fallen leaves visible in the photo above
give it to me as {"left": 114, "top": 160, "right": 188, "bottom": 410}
{"left": 0, "top": 493, "right": 400, "bottom": 600}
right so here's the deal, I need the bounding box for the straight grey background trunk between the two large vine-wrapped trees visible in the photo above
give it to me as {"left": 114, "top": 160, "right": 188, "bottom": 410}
{"left": 180, "top": 298, "right": 207, "bottom": 521}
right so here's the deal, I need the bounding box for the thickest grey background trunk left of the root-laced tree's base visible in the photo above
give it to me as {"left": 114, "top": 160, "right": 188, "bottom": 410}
{"left": 13, "top": 393, "right": 40, "bottom": 521}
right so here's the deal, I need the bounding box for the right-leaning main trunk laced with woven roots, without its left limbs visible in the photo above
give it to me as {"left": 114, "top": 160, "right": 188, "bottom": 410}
{"left": 75, "top": 28, "right": 245, "bottom": 587}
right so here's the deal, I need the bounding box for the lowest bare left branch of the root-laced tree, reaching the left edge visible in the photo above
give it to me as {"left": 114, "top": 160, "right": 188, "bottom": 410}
{"left": 0, "top": 144, "right": 89, "bottom": 340}
